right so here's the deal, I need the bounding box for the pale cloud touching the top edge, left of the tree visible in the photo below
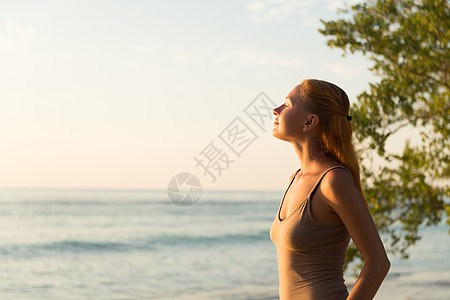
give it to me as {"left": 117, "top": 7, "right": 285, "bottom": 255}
{"left": 238, "top": 0, "right": 314, "bottom": 23}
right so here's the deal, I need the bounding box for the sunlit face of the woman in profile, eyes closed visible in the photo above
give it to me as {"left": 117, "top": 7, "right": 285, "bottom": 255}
{"left": 272, "top": 87, "right": 306, "bottom": 141}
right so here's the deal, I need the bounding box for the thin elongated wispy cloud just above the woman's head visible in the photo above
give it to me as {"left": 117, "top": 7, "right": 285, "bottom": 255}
{"left": 216, "top": 50, "right": 306, "bottom": 67}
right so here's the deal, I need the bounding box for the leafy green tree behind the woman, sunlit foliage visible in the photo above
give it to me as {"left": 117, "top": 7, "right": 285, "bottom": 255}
{"left": 319, "top": 0, "right": 450, "bottom": 272}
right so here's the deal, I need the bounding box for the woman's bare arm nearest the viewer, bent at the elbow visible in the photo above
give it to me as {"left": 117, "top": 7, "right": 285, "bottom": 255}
{"left": 322, "top": 169, "right": 390, "bottom": 300}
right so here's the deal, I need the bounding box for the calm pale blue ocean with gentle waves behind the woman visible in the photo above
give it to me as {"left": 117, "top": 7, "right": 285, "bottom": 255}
{"left": 0, "top": 189, "right": 450, "bottom": 300}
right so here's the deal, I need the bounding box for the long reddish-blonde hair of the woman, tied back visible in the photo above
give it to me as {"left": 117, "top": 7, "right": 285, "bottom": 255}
{"left": 297, "top": 79, "right": 364, "bottom": 197}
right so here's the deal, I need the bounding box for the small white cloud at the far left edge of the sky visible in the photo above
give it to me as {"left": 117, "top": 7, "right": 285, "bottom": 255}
{"left": 0, "top": 19, "right": 36, "bottom": 52}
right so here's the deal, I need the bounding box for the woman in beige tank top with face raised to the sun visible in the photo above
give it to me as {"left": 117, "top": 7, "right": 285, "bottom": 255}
{"left": 270, "top": 79, "right": 390, "bottom": 300}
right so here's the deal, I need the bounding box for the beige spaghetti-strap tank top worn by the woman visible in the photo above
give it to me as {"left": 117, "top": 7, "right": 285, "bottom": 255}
{"left": 270, "top": 166, "right": 351, "bottom": 300}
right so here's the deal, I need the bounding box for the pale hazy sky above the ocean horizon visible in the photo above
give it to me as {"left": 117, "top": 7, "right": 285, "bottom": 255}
{"left": 0, "top": 0, "right": 408, "bottom": 190}
